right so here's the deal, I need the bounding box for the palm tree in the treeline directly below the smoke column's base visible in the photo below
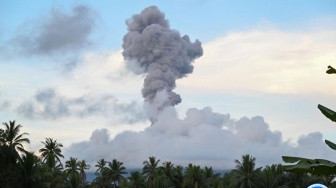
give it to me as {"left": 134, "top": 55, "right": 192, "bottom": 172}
{"left": 142, "top": 157, "right": 160, "bottom": 187}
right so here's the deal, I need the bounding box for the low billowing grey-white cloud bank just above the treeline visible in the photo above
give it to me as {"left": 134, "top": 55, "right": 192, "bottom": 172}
{"left": 65, "top": 107, "right": 333, "bottom": 169}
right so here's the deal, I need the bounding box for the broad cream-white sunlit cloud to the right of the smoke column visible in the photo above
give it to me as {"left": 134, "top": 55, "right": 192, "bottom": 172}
{"left": 178, "top": 28, "right": 336, "bottom": 95}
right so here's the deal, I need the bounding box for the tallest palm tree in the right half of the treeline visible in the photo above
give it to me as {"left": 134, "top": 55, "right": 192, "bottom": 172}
{"left": 230, "top": 154, "right": 261, "bottom": 188}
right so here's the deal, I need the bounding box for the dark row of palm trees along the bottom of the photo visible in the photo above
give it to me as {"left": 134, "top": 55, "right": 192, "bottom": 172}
{"left": 0, "top": 121, "right": 336, "bottom": 188}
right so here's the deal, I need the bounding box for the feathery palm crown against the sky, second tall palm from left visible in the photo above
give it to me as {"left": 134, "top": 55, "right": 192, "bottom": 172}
{"left": 39, "top": 138, "right": 64, "bottom": 168}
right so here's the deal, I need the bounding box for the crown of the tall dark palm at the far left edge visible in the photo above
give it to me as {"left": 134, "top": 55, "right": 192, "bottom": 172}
{"left": 0, "top": 121, "right": 30, "bottom": 153}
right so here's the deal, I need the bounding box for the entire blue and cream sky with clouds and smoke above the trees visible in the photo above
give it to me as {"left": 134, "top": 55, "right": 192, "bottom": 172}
{"left": 0, "top": 0, "right": 336, "bottom": 169}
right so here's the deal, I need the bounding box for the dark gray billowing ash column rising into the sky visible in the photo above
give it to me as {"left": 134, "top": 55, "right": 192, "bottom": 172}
{"left": 122, "top": 6, "right": 203, "bottom": 118}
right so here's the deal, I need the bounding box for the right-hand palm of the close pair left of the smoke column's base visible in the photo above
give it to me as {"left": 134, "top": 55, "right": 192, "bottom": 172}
{"left": 107, "top": 159, "right": 127, "bottom": 187}
